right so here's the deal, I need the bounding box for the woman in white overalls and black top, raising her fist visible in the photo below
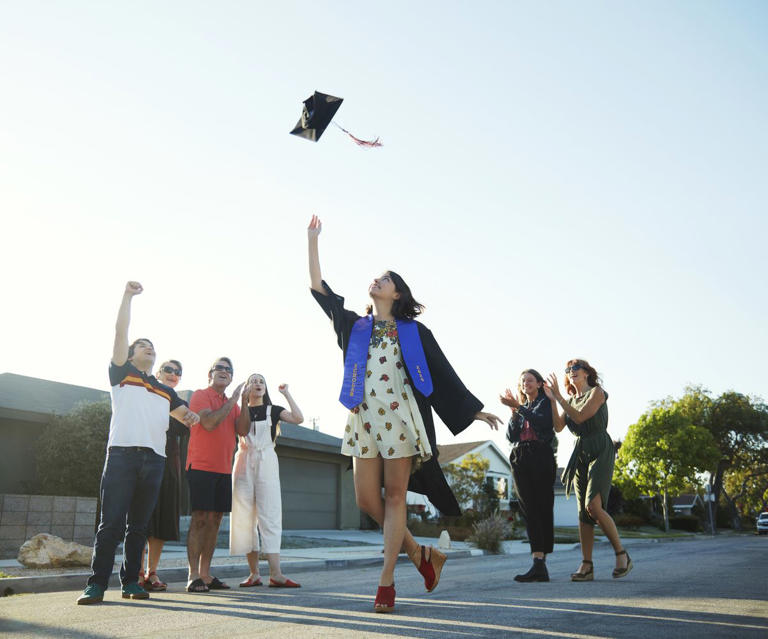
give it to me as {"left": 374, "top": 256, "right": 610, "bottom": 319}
{"left": 229, "top": 374, "right": 304, "bottom": 588}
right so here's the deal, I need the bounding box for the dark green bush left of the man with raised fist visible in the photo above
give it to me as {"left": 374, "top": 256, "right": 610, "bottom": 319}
{"left": 37, "top": 401, "right": 112, "bottom": 497}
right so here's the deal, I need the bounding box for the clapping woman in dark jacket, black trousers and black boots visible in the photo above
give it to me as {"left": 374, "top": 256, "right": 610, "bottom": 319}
{"left": 500, "top": 368, "right": 565, "bottom": 582}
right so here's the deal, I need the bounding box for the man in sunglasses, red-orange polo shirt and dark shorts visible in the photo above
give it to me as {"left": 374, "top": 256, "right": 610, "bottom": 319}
{"left": 187, "top": 357, "right": 243, "bottom": 592}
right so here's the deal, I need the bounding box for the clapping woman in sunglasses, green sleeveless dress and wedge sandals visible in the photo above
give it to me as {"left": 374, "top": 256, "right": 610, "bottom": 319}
{"left": 546, "top": 359, "right": 632, "bottom": 581}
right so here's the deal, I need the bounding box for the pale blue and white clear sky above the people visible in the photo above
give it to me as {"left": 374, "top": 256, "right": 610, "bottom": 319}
{"left": 0, "top": 0, "right": 768, "bottom": 464}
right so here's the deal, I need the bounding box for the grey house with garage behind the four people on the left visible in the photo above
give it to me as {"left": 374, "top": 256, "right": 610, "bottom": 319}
{"left": 0, "top": 373, "right": 360, "bottom": 548}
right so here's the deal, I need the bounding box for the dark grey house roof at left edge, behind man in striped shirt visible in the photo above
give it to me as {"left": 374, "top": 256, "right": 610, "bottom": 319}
{"left": 0, "top": 373, "right": 109, "bottom": 415}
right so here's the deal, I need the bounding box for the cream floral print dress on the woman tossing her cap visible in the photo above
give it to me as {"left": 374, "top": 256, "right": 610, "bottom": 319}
{"left": 341, "top": 320, "right": 432, "bottom": 470}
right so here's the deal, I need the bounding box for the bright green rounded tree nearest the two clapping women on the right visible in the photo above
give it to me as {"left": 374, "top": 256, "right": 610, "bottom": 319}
{"left": 616, "top": 406, "right": 718, "bottom": 530}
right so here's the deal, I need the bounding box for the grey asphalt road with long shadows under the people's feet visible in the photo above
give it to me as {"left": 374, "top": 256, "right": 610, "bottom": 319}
{"left": 0, "top": 536, "right": 768, "bottom": 639}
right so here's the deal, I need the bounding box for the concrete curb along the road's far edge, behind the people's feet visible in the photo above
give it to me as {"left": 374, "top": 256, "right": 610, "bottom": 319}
{"left": 0, "top": 550, "right": 474, "bottom": 597}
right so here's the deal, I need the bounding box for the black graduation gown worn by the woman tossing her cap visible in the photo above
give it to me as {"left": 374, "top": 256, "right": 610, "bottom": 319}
{"left": 312, "top": 281, "right": 483, "bottom": 515}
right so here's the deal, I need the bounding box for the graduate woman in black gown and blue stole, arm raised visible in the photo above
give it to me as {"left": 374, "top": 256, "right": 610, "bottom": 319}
{"left": 307, "top": 216, "right": 501, "bottom": 612}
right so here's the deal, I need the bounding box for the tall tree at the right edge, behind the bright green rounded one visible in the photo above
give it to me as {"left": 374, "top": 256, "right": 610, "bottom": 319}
{"left": 660, "top": 386, "right": 768, "bottom": 529}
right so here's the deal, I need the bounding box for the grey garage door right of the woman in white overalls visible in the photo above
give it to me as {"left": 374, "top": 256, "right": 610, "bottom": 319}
{"left": 280, "top": 457, "right": 339, "bottom": 530}
